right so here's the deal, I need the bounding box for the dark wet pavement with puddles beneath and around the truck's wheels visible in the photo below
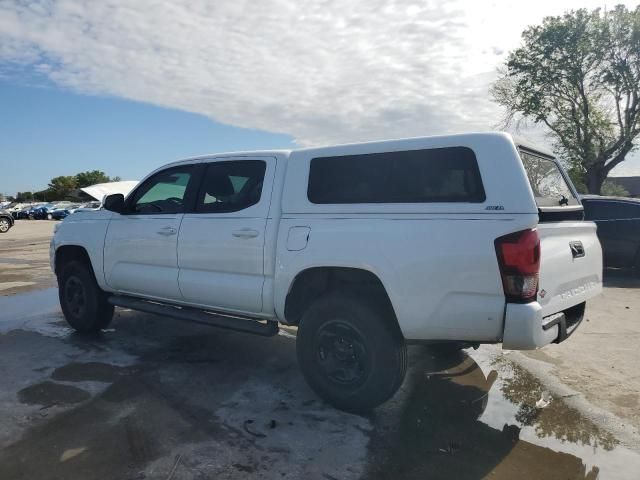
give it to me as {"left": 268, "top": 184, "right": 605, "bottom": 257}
{"left": 0, "top": 289, "right": 640, "bottom": 480}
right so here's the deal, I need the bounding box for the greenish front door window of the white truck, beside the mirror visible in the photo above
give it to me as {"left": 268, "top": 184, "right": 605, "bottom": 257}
{"left": 128, "top": 166, "right": 193, "bottom": 214}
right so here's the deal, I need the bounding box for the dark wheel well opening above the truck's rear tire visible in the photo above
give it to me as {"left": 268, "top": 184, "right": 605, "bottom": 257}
{"left": 284, "top": 267, "right": 397, "bottom": 325}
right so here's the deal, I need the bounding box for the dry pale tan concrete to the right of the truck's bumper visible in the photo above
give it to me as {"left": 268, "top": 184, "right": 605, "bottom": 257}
{"left": 527, "top": 269, "right": 640, "bottom": 432}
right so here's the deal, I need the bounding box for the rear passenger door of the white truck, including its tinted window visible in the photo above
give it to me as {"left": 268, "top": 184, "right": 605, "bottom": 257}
{"left": 178, "top": 157, "right": 276, "bottom": 313}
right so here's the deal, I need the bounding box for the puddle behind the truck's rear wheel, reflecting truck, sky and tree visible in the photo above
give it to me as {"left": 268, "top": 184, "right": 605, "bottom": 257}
{"left": 365, "top": 348, "right": 640, "bottom": 479}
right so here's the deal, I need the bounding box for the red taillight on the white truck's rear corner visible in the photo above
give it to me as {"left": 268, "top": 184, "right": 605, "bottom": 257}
{"left": 495, "top": 229, "right": 540, "bottom": 303}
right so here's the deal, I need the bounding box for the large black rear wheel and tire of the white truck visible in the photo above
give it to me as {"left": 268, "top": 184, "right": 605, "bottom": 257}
{"left": 296, "top": 294, "right": 407, "bottom": 413}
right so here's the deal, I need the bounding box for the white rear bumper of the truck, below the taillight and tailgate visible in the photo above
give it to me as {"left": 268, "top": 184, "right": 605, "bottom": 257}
{"left": 502, "top": 302, "right": 585, "bottom": 350}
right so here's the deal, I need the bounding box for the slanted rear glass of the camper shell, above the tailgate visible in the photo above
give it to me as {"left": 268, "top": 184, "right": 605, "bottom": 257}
{"left": 520, "top": 150, "right": 580, "bottom": 207}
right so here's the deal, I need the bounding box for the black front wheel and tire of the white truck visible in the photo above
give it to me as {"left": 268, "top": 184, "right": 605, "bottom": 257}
{"left": 58, "top": 260, "right": 114, "bottom": 333}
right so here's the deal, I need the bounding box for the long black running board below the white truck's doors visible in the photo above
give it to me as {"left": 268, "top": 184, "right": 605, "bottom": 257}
{"left": 109, "top": 295, "right": 278, "bottom": 337}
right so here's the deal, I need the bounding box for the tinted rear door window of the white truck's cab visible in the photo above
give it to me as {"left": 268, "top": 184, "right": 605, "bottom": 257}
{"left": 196, "top": 160, "right": 267, "bottom": 213}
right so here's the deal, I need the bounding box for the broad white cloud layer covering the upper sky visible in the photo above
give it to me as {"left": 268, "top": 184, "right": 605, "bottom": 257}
{"left": 0, "top": 0, "right": 640, "bottom": 172}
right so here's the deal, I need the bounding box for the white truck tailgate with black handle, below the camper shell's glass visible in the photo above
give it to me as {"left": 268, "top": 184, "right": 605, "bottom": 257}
{"left": 538, "top": 221, "right": 602, "bottom": 317}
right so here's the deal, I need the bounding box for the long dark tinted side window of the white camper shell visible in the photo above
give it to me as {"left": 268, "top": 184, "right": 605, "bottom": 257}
{"left": 307, "top": 147, "right": 485, "bottom": 204}
